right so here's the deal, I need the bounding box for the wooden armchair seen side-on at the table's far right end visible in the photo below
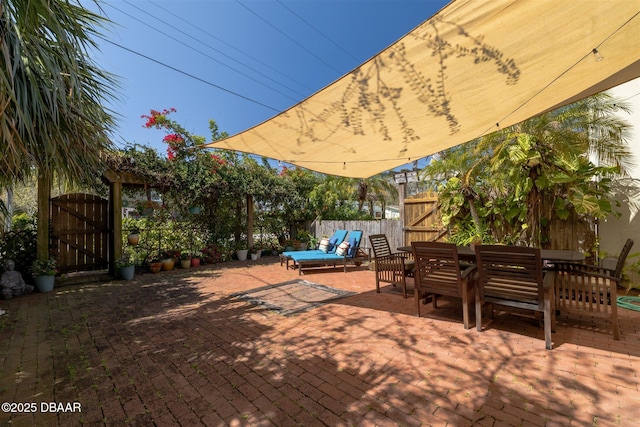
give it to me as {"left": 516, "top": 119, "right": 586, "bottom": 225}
{"left": 554, "top": 239, "right": 633, "bottom": 340}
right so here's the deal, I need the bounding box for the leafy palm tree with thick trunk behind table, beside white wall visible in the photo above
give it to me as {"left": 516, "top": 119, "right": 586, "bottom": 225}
{"left": 478, "top": 93, "right": 632, "bottom": 247}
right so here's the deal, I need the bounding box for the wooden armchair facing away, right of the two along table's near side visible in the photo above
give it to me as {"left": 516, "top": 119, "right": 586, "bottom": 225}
{"left": 475, "top": 245, "right": 555, "bottom": 350}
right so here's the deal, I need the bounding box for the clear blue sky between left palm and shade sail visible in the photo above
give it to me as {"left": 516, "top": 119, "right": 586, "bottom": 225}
{"left": 83, "top": 0, "right": 447, "bottom": 169}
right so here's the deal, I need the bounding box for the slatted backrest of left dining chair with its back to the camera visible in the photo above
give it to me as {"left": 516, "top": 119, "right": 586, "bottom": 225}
{"left": 411, "top": 242, "right": 462, "bottom": 295}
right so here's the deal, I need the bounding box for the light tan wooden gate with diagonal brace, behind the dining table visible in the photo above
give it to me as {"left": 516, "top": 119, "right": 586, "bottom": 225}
{"left": 403, "top": 192, "right": 447, "bottom": 246}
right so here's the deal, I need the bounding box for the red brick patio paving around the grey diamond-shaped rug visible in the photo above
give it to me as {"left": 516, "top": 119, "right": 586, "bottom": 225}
{"left": 0, "top": 258, "right": 640, "bottom": 426}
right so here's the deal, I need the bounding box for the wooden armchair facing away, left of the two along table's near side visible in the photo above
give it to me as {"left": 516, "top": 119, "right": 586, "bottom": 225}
{"left": 411, "top": 242, "right": 476, "bottom": 329}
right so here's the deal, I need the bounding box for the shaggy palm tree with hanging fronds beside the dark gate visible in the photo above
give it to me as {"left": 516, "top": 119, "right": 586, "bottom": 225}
{"left": 0, "top": 0, "right": 116, "bottom": 259}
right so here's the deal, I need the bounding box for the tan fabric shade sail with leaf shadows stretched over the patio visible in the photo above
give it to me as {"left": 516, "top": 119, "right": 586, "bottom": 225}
{"left": 209, "top": 0, "right": 640, "bottom": 178}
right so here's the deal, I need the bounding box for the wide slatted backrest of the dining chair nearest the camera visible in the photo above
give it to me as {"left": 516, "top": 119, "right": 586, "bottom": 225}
{"left": 475, "top": 245, "right": 544, "bottom": 306}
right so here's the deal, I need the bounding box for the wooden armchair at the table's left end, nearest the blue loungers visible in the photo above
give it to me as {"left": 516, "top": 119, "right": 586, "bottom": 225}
{"left": 369, "top": 234, "right": 414, "bottom": 298}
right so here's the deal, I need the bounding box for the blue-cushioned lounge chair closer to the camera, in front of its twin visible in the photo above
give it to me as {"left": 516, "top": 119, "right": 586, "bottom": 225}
{"left": 290, "top": 230, "right": 365, "bottom": 275}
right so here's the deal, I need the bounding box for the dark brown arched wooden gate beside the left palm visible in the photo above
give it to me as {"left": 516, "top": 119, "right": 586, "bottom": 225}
{"left": 51, "top": 193, "right": 110, "bottom": 272}
